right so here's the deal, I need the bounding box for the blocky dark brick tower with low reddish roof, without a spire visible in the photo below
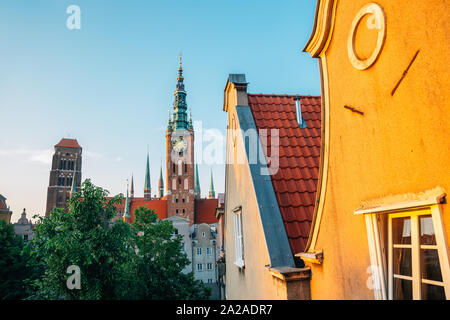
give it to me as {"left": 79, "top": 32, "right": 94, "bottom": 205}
{"left": 45, "top": 139, "right": 83, "bottom": 216}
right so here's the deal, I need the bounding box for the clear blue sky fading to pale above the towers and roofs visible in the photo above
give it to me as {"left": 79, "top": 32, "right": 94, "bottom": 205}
{"left": 0, "top": 0, "right": 320, "bottom": 221}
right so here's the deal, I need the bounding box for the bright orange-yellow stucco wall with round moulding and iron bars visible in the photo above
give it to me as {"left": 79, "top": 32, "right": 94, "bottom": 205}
{"left": 308, "top": 0, "right": 450, "bottom": 299}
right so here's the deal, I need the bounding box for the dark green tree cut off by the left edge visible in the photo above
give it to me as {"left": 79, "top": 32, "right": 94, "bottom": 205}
{"left": 0, "top": 220, "right": 32, "bottom": 300}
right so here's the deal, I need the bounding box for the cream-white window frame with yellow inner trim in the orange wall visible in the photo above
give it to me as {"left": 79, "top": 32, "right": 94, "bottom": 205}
{"left": 355, "top": 194, "right": 450, "bottom": 300}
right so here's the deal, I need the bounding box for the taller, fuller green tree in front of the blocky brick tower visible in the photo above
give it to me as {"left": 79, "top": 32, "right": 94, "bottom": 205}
{"left": 33, "top": 180, "right": 133, "bottom": 300}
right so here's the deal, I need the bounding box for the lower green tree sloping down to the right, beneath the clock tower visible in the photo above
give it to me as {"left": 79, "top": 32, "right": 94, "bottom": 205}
{"left": 128, "top": 207, "right": 210, "bottom": 300}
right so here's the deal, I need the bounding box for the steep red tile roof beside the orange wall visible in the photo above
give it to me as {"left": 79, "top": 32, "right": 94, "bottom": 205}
{"left": 248, "top": 94, "right": 321, "bottom": 254}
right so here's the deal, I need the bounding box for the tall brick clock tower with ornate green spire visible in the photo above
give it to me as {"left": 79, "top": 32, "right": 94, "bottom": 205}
{"left": 166, "top": 55, "right": 195, "bottom": 224}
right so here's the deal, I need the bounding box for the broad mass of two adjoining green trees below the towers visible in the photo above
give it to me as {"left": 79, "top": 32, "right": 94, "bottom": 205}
{"left": 29, "top": 180, "right": 209, "bottom": 300}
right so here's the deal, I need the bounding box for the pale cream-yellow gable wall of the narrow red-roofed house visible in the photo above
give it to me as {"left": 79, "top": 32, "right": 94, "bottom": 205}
{"left": 224, "top": 85, "right": 287, "bottom": 300}
